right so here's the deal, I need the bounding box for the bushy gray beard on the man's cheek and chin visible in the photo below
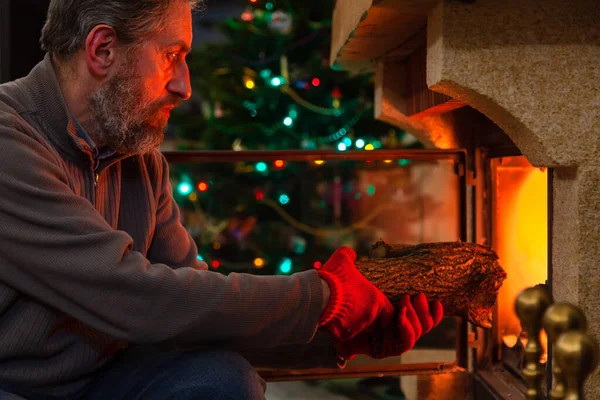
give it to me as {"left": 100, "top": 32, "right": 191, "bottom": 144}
{"left": 89, "top": 61, "right": 166, "bottom": 155}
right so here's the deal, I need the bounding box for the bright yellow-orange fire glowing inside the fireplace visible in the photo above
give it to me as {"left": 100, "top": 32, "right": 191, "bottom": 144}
{"left": 494, "top": 157, "right": 548, "bottom": 361}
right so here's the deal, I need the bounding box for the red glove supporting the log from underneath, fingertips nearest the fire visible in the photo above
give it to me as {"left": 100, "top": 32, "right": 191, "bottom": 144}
{"left": 337, "top": 293, "right": 444, "bottom": 360}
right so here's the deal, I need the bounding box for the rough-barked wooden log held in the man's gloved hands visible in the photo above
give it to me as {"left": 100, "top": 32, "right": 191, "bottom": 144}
{"left": 356, "top": 241, "right": 506, "bottom": 328}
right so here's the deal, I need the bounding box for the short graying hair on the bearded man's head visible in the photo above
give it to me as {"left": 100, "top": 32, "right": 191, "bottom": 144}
{"left": 40, "top": 0, "right": 203, "bottom": 61}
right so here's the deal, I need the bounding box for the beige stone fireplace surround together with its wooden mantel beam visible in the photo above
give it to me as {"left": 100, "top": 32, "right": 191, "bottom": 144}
{"left": 331, "top": 0, "right": 600, "bottom": 399}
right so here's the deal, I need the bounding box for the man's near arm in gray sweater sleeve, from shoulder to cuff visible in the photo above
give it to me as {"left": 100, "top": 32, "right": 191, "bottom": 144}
{"left": 0, "top": 126, "right": 323, "bottom": 348}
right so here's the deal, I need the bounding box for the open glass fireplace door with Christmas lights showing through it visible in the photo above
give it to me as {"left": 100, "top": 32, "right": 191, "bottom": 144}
{"left": 165, "top": 150, "right": 467, "bottom": 380}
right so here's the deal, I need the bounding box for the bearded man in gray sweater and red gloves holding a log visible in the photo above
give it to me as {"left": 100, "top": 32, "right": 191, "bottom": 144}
{"left": 0, "top": 0, "right": 442, "bottom": 400}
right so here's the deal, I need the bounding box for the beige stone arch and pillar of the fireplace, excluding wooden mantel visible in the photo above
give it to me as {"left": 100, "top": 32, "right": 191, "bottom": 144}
{"left": 379, "top": 0, "right": 600, "bottom": 398}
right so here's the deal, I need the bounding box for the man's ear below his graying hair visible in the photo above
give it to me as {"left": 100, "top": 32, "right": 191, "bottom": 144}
{"left": 85, "top": 25, "right": 117, "bottom": 77}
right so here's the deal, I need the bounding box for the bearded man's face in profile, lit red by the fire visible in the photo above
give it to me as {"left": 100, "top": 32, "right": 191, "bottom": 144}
{"left": 89, "top": 2, "right": 192, "bottom": 154}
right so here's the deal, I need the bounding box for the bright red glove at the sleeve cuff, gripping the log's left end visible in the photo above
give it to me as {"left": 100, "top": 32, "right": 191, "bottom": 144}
{"left": 317, "top": 246, "right": 394, "bottom": 342}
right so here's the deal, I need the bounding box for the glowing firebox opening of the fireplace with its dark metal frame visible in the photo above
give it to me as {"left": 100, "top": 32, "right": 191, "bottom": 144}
{"left": 474, "top": 148, "right": 552, "bottom": 400}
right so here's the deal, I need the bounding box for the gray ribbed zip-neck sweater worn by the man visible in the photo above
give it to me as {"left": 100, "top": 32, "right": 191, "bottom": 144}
{"left": 0, "top": 56, "right": 336, "bottom": 395}
